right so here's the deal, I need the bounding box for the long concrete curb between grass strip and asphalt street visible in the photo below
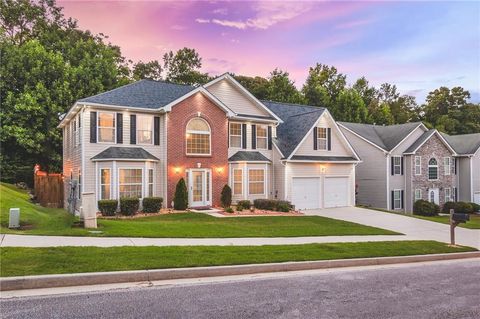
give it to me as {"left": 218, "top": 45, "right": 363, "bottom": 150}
{"left": 0, "top": 251, "right": 480, "bottom": 291}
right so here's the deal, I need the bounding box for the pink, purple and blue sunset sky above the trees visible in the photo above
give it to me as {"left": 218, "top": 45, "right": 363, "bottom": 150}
{"left": 58, "top": 0, "right": 480, "bottom": 103}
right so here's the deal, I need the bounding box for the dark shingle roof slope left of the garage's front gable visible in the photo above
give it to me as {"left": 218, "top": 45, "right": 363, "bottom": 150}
{"left": 261, "top": 101, "right": 325, "bottom": 158}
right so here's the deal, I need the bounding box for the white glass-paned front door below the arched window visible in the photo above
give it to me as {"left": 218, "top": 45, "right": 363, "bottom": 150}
{"left": 188, "top": 169, "right": 212, "bottom": 207}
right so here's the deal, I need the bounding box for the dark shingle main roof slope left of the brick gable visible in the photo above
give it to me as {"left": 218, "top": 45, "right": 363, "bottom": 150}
{"left": 78, "top": 80, "right": 195, "bottom": 109}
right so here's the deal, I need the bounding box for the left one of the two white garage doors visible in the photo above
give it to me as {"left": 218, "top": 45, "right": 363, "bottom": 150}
{"left": 292, "top": 177, "right": 320, "bottom": 209}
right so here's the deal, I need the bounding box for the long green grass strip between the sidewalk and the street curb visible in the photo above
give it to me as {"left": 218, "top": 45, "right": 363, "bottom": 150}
{"left": 0, "top": 241, "right": 475, "bottom": 277}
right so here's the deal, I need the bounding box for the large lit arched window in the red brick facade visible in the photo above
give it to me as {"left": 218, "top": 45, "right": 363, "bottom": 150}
{"left": 186, "top": 118, "right": 211, "bottom": 155}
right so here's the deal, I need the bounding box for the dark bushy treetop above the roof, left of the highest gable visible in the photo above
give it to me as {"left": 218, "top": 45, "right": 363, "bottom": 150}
{"left": 163, "top": 48, "right": 210, "bottom": 84}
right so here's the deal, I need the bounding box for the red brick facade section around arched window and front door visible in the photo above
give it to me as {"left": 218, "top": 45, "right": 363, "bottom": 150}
{"left": 167, "top": 93, "right": 228, "bottom": 207}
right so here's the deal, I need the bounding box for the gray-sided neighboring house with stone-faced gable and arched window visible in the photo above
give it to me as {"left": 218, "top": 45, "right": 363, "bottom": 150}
{"left": 339, "top": 122, "right": 459, "bottom": 212}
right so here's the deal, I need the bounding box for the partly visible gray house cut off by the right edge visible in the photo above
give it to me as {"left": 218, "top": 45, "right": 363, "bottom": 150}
{"left": 442, "top": 133, "right": 480, "bottom": 204}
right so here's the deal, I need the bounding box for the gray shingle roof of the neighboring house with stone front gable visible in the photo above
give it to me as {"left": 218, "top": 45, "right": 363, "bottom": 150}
{"left": 338, "top": 122, "right": 422, "bottom": 151}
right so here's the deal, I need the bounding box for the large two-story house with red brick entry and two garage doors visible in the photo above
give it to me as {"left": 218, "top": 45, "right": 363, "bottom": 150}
{"left": 59, "top": 74, "right": 360, "bottom": 215}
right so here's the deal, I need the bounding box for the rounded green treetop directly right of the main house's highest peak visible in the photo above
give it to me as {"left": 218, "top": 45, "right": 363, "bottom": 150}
{"left": 266, "top": 69, "right": 302, "bottom": 103}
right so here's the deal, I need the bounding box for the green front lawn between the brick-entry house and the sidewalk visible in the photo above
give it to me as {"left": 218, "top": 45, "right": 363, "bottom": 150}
{"left": 0, "top": 184, "right": 398, "bottom": 238}
